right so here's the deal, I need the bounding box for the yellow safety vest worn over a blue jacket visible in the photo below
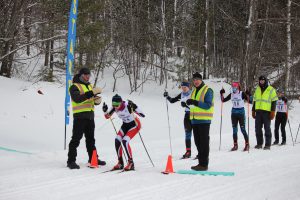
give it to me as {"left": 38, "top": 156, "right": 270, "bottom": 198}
{"left": 190, "top": 85, "right": 214, "bottom": 120}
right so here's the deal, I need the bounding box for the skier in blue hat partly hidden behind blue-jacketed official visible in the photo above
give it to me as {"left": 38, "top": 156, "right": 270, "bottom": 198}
{"left": 164, "top": 81, "right": 192, "bottom": 159}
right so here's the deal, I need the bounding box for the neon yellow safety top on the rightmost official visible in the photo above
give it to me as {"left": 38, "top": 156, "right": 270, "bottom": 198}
{"left": 253, "top": 85, "right": 278, "bottom": 112}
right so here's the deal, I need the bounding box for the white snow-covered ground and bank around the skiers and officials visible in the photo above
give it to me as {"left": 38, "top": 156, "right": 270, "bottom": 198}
{"left": 0, "top": 74, "right": 300, "bottom": 200}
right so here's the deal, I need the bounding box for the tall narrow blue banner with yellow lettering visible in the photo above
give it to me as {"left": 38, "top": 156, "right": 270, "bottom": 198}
{"left": 65, "top": 0, "right": 79, "bottom": 125}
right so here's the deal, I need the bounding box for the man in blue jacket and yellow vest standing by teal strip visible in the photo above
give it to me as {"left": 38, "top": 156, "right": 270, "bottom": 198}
{"left": 186, "top": 72, "right": 214, "bottom": 171}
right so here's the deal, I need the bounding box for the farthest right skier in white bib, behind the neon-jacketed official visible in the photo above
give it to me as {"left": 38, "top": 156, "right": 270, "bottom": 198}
{"left": 273, "top": 89, "right": 288, "bottom": 145}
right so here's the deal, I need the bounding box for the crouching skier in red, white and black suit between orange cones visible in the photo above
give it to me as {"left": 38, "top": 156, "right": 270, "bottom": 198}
{"left": 102, "top": 94, "right": 145, "bottom": 171}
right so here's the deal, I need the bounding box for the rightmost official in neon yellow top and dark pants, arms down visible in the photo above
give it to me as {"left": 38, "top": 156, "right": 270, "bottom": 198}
{"left": 252, "top": 76, "right": 278, "bottom": 150}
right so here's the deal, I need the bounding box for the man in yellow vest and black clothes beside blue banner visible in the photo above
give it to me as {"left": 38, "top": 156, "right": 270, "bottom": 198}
{"left": 67, "top": 68, "right": 106, "bottom": 169}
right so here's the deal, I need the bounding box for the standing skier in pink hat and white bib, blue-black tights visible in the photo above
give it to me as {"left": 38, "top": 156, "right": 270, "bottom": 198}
{"left": 220, "top": 82, "right": 249, "bottom": 151}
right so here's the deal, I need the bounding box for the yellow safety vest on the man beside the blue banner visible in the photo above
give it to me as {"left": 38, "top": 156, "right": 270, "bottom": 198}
{"left": 72, "top": 83, "right": 94, "bottom": 114}
